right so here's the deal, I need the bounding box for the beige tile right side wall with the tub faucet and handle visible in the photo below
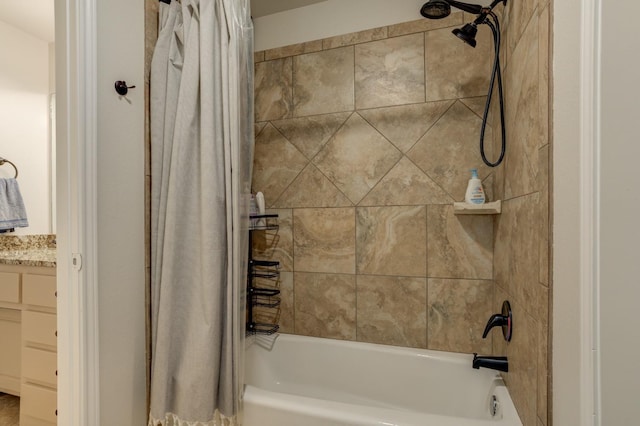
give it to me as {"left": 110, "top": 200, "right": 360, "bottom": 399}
{"left": 494, "top": 0, "right": 552, "bottom": 426}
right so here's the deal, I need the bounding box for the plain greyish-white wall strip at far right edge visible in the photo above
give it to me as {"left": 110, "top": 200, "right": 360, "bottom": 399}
{"left": 600, "top": 1, "right": 640, "bottom": 426}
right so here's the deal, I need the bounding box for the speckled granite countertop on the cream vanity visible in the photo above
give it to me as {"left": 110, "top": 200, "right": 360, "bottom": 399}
{"left": 0, "top": 235, "right": 56, "bottom": 268}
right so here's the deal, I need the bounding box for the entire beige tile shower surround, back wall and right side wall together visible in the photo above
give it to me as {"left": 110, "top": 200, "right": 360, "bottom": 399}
{"left": 253, "top": 0, "right": 551, "bottom": 426}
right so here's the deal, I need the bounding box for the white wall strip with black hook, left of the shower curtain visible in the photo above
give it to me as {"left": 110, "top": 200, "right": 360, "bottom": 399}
{"left": 95, "top": 0, "right": 147, "bottom": 426}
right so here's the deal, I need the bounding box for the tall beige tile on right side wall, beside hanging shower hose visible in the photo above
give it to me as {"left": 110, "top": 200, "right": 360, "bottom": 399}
{"left": 505, "top": 12, "right": 540, "bottom": 199}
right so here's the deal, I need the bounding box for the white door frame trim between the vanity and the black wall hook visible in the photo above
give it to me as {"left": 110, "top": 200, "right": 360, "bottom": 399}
{"left": 55, "top": 0, "right": 100, "bottom": 426}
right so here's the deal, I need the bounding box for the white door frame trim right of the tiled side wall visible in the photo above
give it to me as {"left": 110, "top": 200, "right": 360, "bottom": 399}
{"left": 552, "top": 0, "right": 601, "bottom": 426}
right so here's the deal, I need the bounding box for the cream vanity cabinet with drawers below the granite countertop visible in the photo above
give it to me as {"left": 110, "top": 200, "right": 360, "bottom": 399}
{"left": 0, "top": 265, "right": 58, "bottom": 426}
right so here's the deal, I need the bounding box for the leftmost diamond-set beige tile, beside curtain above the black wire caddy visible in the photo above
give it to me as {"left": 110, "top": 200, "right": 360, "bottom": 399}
{"left": 252, "top": 124, "right": 308, "bottom": 207}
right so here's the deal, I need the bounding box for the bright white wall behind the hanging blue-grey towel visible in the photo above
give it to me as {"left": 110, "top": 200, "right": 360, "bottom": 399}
{"left": 0, "top": 21, "right": 51, "bottom": 234}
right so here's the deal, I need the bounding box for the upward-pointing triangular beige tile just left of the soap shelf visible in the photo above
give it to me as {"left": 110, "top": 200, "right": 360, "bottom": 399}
{"left": 359, "top": 157, "right": 453, "bottom": 206}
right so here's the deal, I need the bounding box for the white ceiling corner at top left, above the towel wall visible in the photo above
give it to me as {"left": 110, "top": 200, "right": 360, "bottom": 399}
{"left": 0, "top": 0, "right": 55, "bottom": 42}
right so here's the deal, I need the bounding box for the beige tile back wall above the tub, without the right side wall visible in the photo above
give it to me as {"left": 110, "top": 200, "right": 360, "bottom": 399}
{"left": 253, "top": 12, "right": 495, "bottom": 353}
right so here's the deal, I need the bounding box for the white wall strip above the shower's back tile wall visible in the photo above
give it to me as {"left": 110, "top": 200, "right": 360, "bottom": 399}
{"left": 254, "top": 0, "right": 426, "bottom": 52}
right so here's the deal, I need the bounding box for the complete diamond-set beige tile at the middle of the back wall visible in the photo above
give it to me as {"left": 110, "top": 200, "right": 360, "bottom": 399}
{"left": 313, "top": 114, "right": 402, "bottom": 204}
